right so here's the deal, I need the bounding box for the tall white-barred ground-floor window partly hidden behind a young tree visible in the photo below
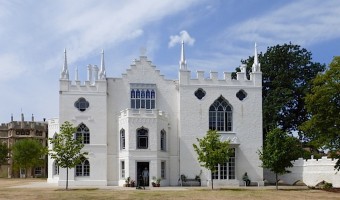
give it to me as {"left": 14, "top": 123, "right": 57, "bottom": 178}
{"left": 212, "top": 148, "right": 235, "bottom": 180}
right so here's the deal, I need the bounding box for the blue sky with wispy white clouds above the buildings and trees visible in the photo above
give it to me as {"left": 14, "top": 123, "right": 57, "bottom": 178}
{"left": 0, "top": 0, "right": 340, "bottom": 122}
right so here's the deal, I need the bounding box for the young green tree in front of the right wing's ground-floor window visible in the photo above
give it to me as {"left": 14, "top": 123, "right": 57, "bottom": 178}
{"left": 193, "top": 130, "right": 232, "bottom": 189}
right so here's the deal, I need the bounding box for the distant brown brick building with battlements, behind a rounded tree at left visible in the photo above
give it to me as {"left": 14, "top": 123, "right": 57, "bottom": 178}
{"left": 0, "top": 114, "right": 48, "bottom": 178}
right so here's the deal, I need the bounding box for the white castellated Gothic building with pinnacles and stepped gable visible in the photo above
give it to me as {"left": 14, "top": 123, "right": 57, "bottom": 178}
{"left": 48, "top": 43, "right": 263, "bottom": 186}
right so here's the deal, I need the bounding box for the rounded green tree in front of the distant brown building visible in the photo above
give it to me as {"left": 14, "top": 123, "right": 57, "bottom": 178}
{"left": 12, "top": 139, "right": 47, "bottom": 178}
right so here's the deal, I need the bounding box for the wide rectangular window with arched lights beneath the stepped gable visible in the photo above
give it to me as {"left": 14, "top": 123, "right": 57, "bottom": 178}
{"left": 130, "top": 84, "right": 156, "bottom": 109}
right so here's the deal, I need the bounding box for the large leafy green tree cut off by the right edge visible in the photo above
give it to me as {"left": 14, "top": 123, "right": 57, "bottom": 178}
{"left": 301, "top": 56, "right": 340, "bottom": 171}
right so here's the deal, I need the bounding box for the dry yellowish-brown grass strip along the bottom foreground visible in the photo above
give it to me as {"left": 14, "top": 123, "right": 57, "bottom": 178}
{"left": 0, "top": 179, "right": 340, "bottom": 200}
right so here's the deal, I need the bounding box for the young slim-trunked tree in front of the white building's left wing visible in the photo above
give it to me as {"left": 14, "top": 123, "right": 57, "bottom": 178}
{"left": 49, "top": 121, "right": 88, "bottom": 190}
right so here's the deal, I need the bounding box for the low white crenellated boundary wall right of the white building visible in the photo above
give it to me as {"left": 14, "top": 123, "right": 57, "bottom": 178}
{"left": 264, "top": 157, "right": 340, "bottom": 187}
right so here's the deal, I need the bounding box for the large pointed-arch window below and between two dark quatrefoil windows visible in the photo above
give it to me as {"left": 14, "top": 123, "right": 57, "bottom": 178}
{"left": 209, "top": 96, "right": 233, "bottom": 131}
